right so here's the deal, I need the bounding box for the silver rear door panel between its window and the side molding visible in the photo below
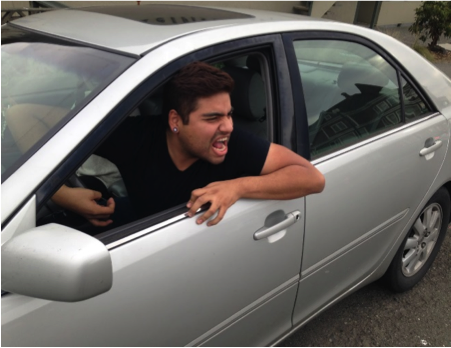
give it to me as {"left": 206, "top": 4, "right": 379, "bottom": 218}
{"left": 302, "top": 115, "right": 450, "bottom": 274}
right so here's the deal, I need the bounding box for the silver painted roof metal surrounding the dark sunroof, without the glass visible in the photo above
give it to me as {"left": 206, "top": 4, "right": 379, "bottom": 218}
{"left": 9, "top": 6, "right": 322, "bottom": 55}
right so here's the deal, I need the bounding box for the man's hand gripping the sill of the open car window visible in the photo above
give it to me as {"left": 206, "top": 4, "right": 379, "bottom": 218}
{"left": 186, "top": 180, "right": 241, "bottom": 226}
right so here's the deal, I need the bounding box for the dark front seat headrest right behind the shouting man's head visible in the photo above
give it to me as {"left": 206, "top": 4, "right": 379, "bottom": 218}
{"left": 224, "top": 67, "right": 266, "bottom": 121}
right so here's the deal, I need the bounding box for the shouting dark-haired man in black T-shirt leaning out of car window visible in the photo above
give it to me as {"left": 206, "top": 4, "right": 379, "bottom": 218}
{"left": 53, "top": 62, "right": 325, "bottom": 226}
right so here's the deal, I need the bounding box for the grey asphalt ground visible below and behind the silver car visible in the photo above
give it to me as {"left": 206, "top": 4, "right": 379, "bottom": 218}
{"left": 279, "top": 27, "right": 451, "bottom": 347}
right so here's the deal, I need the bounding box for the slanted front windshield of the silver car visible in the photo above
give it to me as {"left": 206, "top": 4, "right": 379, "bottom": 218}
{"left": 1, "top": 26, "right": 134, "bottom": 183}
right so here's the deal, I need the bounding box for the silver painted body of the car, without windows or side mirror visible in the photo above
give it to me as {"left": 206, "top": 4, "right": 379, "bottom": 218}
{"left": 1, "top": 4, "right": 451, "bottom": 346}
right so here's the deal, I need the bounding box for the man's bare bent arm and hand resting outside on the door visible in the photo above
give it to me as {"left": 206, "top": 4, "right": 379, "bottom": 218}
{"left": 187, "top": 144, "right": 325, "bottom": 226}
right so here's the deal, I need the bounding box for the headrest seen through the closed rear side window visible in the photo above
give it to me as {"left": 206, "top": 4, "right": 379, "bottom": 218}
{"left": 337, "top": 63, "right": 388, "bottom": 95}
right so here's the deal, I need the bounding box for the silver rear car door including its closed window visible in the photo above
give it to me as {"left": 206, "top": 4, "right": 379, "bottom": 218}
{"left": 285, "top": 33, "right": 449, "bottom": 324}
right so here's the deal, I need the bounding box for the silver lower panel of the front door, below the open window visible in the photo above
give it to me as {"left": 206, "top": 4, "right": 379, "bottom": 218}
{"left": 2, "top": 198, "right": 304, "bottom": 346}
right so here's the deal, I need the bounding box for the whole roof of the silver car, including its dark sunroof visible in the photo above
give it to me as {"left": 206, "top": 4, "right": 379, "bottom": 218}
{"left": 8, "top": 5, "right": 325, "bottom": 55}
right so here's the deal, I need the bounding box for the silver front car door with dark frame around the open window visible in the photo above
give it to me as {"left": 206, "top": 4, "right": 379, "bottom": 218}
{"left": 2, "top": 36, "right": 304, "bottom": 346}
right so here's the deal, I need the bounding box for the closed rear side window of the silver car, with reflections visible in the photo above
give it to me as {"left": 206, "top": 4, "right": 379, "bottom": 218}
{"left": 294, "top": 40, "right": 427, "bottom": 158}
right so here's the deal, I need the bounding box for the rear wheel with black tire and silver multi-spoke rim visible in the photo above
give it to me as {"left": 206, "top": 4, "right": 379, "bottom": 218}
{"left": 384, "top": 188, "right": 451, "bottom": 292}
